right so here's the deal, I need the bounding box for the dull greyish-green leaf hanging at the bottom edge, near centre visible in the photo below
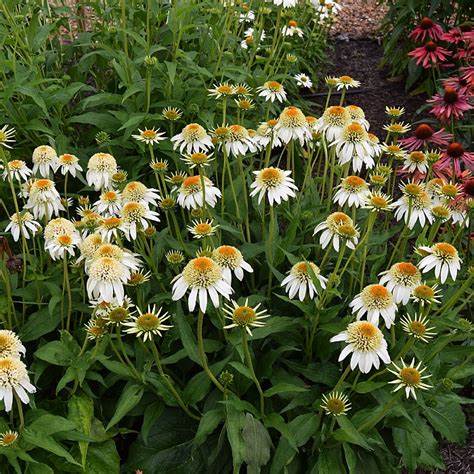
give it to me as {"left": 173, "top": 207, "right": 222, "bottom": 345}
{"left": 242, "top": 413, "right": 272, "bottom": 472}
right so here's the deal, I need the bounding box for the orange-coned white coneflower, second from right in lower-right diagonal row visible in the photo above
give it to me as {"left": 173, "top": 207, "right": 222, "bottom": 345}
{"left": 379, "top": 262, "right": 421, "bottom": 304}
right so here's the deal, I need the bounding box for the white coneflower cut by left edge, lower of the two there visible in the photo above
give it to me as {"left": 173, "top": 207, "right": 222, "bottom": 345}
{"left": 0, "top": 357, "right": 36, "bottom": 412}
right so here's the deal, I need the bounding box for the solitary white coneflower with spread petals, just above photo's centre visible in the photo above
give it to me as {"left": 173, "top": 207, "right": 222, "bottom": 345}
{"left": 250, "top": 167, "right": 298, "bottom": 206}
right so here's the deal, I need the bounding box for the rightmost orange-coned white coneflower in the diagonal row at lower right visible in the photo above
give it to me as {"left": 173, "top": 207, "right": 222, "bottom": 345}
{"left": 418, "top": 242, "right": 462, "bottom": 283}
